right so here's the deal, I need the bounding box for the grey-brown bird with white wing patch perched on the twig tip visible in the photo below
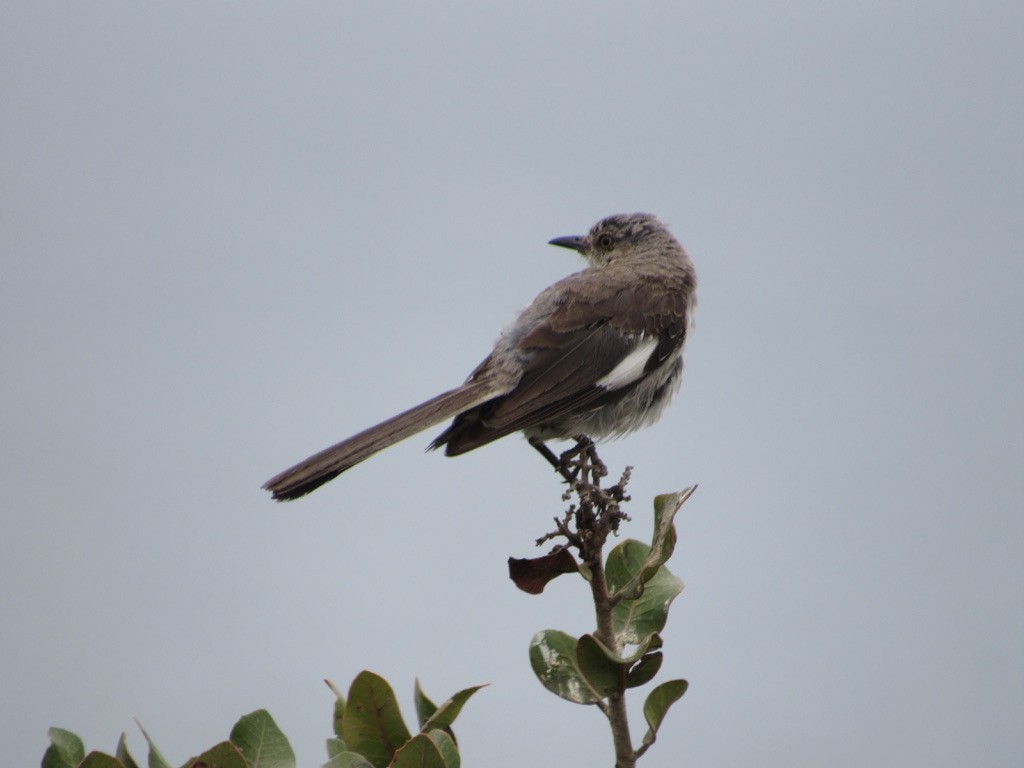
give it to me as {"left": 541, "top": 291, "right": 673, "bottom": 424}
{"left": 263, "top": 213, "right": 696, "bottom": 501}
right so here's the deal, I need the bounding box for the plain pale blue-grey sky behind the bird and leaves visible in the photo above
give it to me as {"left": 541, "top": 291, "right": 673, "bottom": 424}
{"left": 0, "top": 0, "right": 1024, "bottom": 768}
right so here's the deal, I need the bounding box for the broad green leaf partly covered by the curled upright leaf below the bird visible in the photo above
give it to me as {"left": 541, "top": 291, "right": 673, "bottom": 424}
{"left": 608, "top": 539, "right": 683, "bottom": 645}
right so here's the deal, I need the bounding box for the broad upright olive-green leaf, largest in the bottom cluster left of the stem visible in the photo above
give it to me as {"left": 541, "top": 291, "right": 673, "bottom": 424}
{"left": 341, "top": 672, "right": 412, "bottom": 768}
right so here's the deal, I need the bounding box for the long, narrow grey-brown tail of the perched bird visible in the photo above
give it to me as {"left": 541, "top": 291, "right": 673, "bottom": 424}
{"left": 263, "top": 382, "right": 500, "bottom": 501}
